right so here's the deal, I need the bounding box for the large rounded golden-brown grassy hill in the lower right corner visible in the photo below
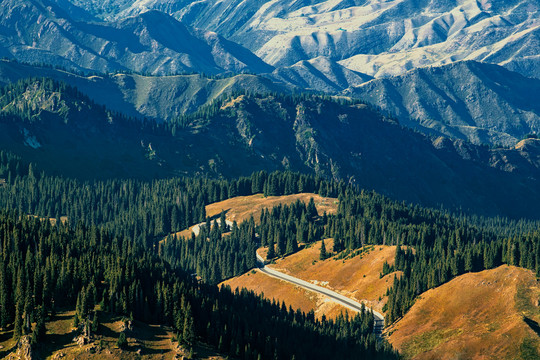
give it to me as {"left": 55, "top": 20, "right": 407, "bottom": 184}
{"left": 388, "top": 265, "right": 540, "bottom": 359}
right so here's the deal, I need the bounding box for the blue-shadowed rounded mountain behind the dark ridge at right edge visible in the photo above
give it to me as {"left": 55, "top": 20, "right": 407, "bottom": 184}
{"left": 347, "top": 61, "right": 540, "bottom": 146}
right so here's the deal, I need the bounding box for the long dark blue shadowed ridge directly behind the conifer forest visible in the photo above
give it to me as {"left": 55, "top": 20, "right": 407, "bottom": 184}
{"left": 0, "top": 80, "right": 540, "bottom": 218}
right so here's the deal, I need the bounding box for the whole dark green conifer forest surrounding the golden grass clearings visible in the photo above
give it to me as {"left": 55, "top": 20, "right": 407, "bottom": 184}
{"left": 0, "top": 153, "right": 540, "bottom": 358}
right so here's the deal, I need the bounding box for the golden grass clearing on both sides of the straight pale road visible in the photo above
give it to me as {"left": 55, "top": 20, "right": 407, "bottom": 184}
{"left": 225, "top": 239, "right": 395, "bottom": 318}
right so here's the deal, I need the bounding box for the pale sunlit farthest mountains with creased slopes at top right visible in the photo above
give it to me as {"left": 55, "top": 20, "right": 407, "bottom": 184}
{"left": 68, "top": 0, "right": 540, "bottom": 78}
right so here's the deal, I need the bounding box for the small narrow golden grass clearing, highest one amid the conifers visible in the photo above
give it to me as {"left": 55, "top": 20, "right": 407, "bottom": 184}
{"left": 206, "top": 193, "right": 338, "bottom": 223}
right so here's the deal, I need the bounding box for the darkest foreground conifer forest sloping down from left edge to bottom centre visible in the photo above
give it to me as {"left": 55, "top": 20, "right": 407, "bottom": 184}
{"left": 0, "top": 211, "right": 397, "bottom": 359}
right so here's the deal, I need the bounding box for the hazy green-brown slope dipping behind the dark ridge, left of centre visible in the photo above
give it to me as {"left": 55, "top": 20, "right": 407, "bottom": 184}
{"left": 0, "top": 60, "right": 292, "bottom": 122}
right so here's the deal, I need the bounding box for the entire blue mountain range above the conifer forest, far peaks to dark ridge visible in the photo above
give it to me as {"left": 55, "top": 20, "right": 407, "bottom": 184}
{"left": 0, "top": 0, "right": 540, "bottom": 217}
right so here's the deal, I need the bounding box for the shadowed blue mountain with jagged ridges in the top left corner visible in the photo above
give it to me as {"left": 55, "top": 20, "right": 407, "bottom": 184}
{"left": 0, "top": 0, "right": 272, "bottom": 74}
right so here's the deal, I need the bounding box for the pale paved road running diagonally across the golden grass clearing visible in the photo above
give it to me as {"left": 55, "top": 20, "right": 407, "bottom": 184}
{"left": 257, "top": 253, "right": 384, "bottom": 337}
